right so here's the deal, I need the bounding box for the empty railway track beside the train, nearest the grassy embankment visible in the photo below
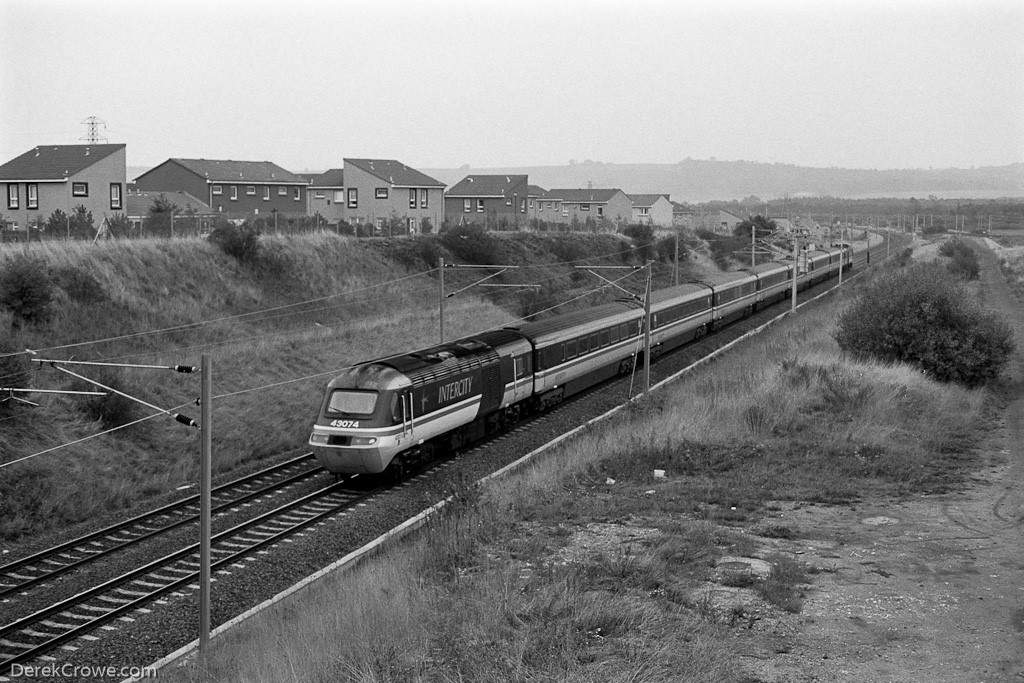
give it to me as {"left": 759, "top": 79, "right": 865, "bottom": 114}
{"left": 0, "top": 454, "right": 323, "bottom": 601}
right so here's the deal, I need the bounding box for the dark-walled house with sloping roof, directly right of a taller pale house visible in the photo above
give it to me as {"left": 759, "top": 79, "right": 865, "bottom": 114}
{"left": 444, "top": 175, "right": 529, "bottom": 229}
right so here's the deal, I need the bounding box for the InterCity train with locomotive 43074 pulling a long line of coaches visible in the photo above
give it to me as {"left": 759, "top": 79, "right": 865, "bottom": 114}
{"left": 308, "top": 236, "right": 871, "bottom": 477}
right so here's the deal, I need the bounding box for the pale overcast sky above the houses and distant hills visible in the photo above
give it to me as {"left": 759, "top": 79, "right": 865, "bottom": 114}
{"left": 0, "top": 0, "right": 1024, "bottom": 172}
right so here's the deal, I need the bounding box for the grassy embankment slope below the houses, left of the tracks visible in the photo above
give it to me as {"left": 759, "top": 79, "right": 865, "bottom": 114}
{"left": 0, "top": 234, "right": 655, "bottom": 540}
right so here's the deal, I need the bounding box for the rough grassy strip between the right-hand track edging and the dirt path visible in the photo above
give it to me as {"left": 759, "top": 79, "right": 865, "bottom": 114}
{"left": 178, "top": 274, "right": 985, "bottom": 683}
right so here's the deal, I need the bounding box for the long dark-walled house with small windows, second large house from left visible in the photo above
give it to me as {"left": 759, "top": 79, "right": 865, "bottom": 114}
{"left": 135, "top": 159, "right": 308, "bottom": 220}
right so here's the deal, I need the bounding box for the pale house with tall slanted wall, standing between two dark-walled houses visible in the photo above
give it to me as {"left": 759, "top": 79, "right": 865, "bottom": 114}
{"left": 344, "top": 159, "right": 444, "bottom": 234}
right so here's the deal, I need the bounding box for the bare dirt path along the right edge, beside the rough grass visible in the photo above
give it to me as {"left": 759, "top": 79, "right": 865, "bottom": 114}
{"left": 751, "top": 245, "right": 1024, "bottom": 683}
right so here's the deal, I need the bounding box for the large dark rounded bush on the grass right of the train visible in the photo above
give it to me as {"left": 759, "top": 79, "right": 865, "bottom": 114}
{"left": 835, "top": 264, "right": 1014, "bottom": 386}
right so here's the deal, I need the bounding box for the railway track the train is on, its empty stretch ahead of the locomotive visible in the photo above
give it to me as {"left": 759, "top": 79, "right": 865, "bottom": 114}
{"left": 0, "top": 480, "right": 380, "bottom": 676}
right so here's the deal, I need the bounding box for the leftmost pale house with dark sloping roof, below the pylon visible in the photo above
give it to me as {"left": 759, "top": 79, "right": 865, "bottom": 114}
{"left": 0, "top": 144, "right": 127, "bottom": 230}
